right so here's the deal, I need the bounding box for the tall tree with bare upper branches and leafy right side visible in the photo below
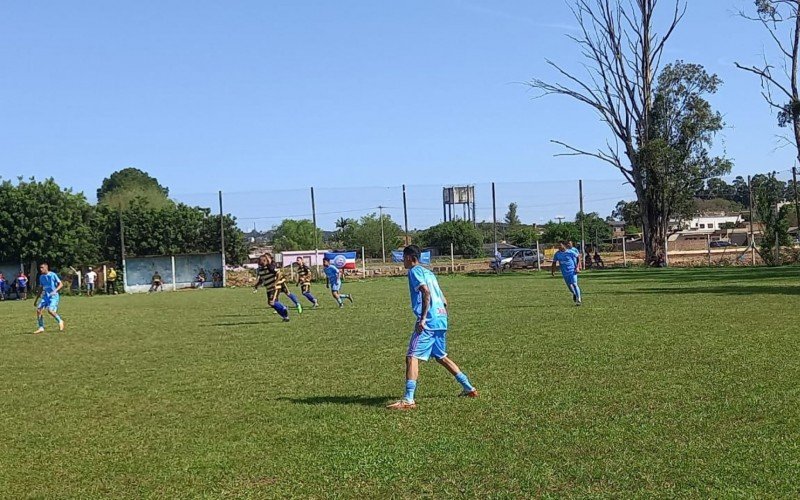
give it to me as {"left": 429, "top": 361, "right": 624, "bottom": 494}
{"left": 531, "top": 0, "right": 730, "bottom": 265}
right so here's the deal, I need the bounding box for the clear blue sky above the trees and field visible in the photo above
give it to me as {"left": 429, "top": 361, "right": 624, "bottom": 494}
{"left": 0, "top": 0, "right": 794, "bottom": 228}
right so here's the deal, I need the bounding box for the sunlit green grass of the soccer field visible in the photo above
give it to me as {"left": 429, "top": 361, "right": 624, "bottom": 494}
{"left": 0, "top": 268, "right": 800, "bottom": 498}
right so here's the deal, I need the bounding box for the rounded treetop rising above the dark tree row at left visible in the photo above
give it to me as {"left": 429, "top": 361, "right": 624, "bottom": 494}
{"left": 97, "top": 168, "right": 173, "bottom": 210}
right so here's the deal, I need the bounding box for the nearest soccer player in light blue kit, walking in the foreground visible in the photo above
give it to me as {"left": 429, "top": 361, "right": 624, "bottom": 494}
{"left": 387, "top": 245, "right": 478, "bottom": 410}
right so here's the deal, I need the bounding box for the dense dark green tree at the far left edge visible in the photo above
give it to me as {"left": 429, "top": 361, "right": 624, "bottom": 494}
{"left": 0, "top": 178, "right": 98, "bottom": 270}
